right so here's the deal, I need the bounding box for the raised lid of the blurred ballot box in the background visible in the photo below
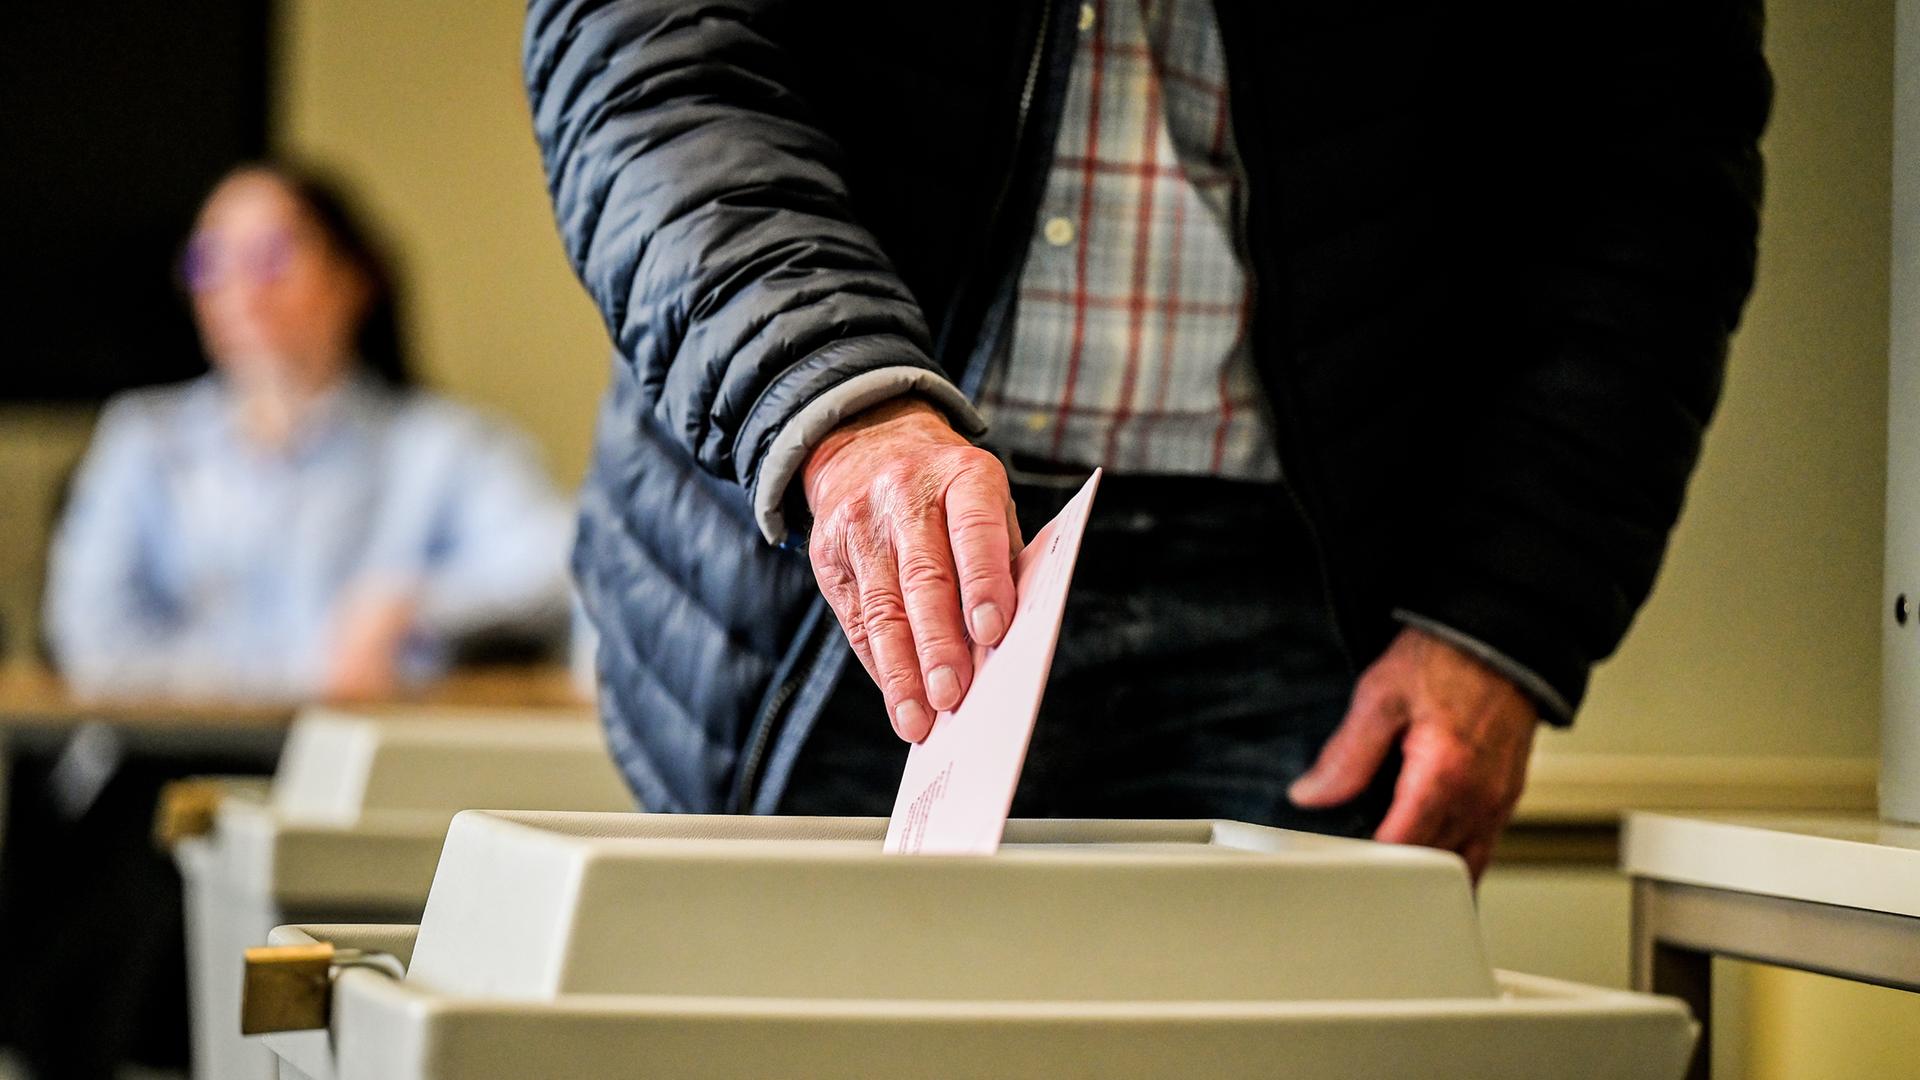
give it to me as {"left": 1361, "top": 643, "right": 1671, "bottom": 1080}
{"left": 271, "top": 705, "right": 634, "bottom": 824}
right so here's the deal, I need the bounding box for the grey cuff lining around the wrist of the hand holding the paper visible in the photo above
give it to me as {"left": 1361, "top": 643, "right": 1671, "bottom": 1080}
{"left": 753, "top": 363, "right": 987, "bottom": 544}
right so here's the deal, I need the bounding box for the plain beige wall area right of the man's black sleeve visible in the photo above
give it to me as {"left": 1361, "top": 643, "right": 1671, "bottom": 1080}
{"left": 1555, "top": 0, "right": 1893, "bottom": 753}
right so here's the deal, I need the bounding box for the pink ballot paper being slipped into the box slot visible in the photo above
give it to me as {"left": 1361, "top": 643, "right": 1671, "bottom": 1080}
{"left": 885, "top": 469, "right": 1100, "bottom": 855}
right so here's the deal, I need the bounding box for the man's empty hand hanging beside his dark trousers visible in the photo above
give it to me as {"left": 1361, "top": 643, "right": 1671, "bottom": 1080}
{"left": 1288, "top": 628, "right": 1538, "bottom": 880}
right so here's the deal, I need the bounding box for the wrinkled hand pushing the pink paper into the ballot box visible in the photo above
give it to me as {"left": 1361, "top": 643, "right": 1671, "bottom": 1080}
{"left": 803, "top": 398, "right": 1021, "bottom": 742}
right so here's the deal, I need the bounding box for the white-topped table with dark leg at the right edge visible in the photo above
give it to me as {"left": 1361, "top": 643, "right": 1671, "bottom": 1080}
{"left": 1620, "top": 813, "right": 1920, "bottom": 1080}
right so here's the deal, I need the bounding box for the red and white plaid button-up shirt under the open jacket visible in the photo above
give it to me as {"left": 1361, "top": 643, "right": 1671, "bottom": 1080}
{"left": 979, "top": 0, "right": 1279, "bottom": 480}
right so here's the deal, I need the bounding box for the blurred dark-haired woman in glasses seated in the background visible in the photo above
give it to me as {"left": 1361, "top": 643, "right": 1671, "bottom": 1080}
{"left": 46, "top": 165, "right": 572, "bottom": 700}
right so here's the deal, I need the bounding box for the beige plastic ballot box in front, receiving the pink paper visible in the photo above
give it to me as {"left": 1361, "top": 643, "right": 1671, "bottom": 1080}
{"left": 246, "top": 813, "right": 1695, "bottom": 1080}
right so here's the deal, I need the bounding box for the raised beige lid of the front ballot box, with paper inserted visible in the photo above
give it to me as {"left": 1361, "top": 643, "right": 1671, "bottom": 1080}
{"left": 407, "top": 811, "right": 1498, "bottom": 1003}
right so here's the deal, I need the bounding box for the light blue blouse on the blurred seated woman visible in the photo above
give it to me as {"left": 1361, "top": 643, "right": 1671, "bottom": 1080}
{"left": 46, "top": 375, "right": 572, "bottom": 700}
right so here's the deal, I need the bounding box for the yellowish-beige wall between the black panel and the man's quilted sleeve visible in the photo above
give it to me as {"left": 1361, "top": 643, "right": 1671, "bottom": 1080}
{"left": 275, "top": 0, "right": 607, "bottom": 484}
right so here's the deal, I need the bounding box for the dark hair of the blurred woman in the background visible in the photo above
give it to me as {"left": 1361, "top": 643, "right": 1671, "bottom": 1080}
{"left": 192, "top": 161, "right": 419, "bottom": 390}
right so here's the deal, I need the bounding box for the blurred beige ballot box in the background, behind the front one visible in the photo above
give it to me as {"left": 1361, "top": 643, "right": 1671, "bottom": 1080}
{"left": 173, "top": 707, "right": 634, "bottom": 1080}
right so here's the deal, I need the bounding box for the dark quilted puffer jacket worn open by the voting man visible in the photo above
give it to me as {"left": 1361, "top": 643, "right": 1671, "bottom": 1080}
{"left": 526, "top": 0, "right": 1770, "bottom": 811}
